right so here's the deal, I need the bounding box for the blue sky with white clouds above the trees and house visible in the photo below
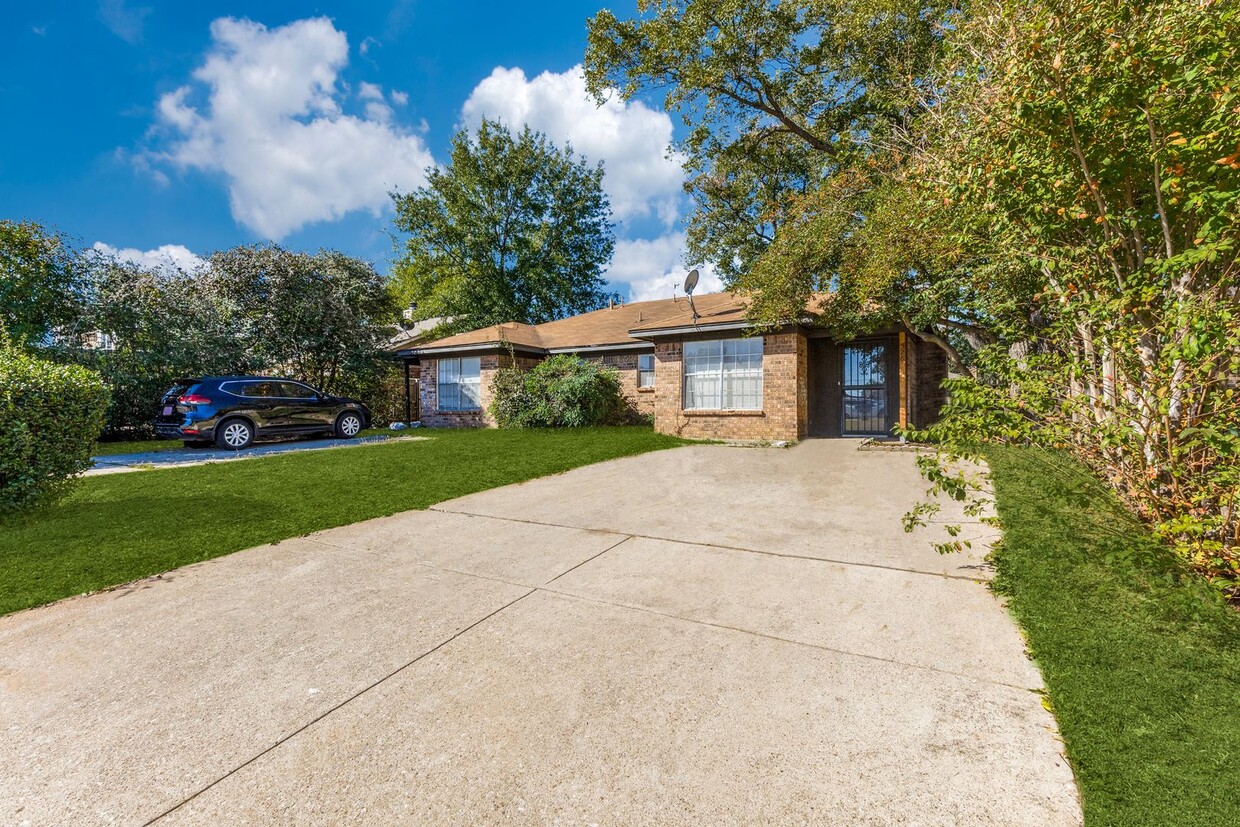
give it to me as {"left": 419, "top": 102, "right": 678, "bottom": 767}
{"left": 0, "top": 0, "right": 717, "bottom": 299}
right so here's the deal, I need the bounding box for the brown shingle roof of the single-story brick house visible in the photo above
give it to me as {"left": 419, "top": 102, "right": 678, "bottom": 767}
{"left": 403, "top": 293, "right": 822, "bottom": 355}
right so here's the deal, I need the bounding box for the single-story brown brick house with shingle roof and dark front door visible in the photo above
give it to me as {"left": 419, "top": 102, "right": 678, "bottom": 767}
{"left": 397, "top": 293, "right": 947, "bottom": 440}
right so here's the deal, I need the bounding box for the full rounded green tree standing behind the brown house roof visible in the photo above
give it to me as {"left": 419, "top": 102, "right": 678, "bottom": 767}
{"left": 393, "top": 120, "right": 615, "bottom": 330}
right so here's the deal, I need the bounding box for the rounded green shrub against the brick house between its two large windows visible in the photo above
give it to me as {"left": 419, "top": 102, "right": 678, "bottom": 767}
{"left": 491, "top": 353, "right": 632, "bottom": 428}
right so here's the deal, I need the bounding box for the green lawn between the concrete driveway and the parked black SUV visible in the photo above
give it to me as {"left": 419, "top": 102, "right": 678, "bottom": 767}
{"left": 0, "top": 428, "right": 684, "bottom": 614}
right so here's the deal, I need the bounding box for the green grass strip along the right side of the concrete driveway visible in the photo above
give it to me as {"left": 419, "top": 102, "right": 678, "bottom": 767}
{"left": 988, "top": 448, "right": 1240, "bottom": 827}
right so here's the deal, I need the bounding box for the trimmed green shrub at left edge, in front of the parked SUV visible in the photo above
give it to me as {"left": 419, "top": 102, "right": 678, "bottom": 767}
{"left": 0, "top": 343, "right": 108, "bottom": 512}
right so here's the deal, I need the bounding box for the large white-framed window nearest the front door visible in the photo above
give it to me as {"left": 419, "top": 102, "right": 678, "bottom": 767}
{"left": 684, "top": 336, "right": 763, "bottom": 410}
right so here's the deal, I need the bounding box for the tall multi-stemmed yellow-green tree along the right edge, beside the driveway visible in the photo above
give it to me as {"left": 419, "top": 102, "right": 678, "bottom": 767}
{"left": 913, "top": 0, "right": 1240, "bottom": 583}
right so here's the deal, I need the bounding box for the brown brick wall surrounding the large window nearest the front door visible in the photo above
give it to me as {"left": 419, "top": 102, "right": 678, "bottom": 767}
{"left": 655, "top": 332, "right": 808, "bottom": 440}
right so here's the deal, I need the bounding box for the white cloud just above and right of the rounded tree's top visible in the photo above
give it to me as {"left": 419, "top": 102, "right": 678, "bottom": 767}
{"left": 461, "top": 66, "right": 684, "bottom": 226}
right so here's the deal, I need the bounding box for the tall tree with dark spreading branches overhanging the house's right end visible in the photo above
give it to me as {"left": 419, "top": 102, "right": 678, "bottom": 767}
{"left": 585, "top": 0, "right": 956, "bottom": 297}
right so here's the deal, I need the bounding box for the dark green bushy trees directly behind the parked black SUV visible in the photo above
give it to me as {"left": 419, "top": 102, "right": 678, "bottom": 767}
{"left": 73, "top": 240, "right": 397, "bottom": 435}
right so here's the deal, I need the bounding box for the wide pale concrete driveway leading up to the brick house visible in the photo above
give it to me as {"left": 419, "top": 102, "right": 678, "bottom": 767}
{"left": 0, "top": 440, "right": 1080, "bottom": 827}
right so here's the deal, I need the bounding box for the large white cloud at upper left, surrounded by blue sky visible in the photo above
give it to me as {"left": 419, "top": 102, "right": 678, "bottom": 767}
{"left": 146, "top": 17, "right": 434, "bottom": 239}
